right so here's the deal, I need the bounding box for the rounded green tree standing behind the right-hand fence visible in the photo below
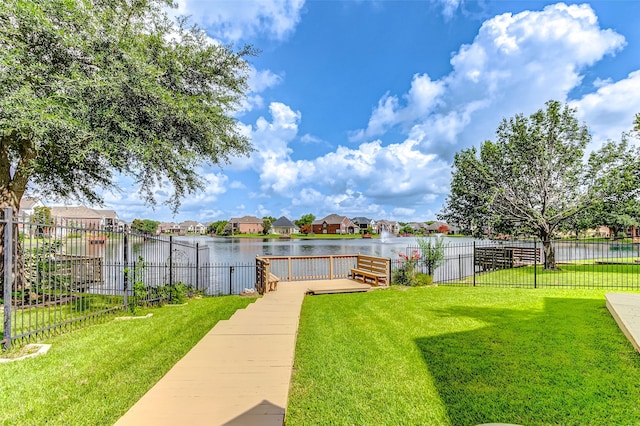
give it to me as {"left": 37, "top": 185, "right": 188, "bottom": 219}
{"left": 439, "top": 101, "right": 627, "bottom": 269}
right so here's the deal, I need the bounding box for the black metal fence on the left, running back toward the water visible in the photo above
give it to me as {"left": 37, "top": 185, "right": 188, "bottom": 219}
{"left": 0, "top": 209, "right": 255, "bottom": 347}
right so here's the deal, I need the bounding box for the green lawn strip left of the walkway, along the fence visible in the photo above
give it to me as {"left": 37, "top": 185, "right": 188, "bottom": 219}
{"left": 0, "top": 296, "right": 252, "bottom": 425}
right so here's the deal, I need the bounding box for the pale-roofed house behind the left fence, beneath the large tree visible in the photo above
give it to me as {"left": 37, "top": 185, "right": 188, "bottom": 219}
{"left": 51, "top": 206, "right": 124, "bottom": 231}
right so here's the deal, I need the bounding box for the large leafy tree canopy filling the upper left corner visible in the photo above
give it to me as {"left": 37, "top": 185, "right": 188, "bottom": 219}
{"left": 0, "top": 0, "right": 254, "bottom": 211}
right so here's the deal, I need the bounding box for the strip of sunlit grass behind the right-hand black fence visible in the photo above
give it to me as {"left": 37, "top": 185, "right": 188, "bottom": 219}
{"left": 461, "top": 261, "right": 640, "bottom": 290}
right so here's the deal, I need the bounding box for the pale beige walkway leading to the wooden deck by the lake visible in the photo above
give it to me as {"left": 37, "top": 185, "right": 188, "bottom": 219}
{"left": 116, "top": 280, "right": 371, "bottom": 426}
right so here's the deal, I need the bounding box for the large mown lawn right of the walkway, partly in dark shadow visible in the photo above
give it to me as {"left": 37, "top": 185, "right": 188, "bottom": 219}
{"left": 286, "top": 286, "right": 640, "bottom": 426}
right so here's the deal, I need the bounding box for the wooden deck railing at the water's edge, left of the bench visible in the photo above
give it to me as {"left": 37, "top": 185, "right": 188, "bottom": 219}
{"left": 256, "top": 254, "right": 358, "bottom": 294}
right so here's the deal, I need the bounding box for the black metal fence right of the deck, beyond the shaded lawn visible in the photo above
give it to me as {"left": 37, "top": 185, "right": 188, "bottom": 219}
{"left": 392, "top": 240, "right": 640, "bottom": 290}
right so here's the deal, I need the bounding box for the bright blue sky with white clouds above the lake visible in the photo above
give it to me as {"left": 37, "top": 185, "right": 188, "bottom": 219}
{"left": 100, "top": 0, "right": 640, "bottom": 222}
